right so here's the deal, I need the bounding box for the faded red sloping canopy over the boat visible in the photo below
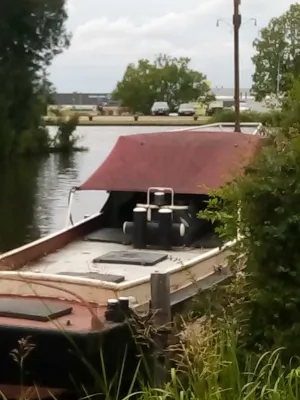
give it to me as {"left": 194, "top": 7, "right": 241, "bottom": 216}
{"left": 78, "top": 131, "right": 261, "bottom": 194}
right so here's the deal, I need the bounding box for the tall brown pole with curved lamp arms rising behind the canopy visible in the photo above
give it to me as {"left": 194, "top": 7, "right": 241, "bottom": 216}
{"left": 232, "top": 0, "right": 242, "bottom": 132}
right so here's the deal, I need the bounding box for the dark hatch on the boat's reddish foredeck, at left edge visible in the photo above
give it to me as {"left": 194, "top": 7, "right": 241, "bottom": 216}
{"left": 0, "top": 298, "right": 73, "bottom": 322}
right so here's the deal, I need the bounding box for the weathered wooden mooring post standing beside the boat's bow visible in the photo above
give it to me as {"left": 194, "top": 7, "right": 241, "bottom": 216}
{"left": 150, "top": 272, "right": 171, "bottom": 388}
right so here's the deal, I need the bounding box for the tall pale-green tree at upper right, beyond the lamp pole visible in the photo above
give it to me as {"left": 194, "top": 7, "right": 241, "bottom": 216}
{"left": 252, "top": 3, "right": 300, "bottom": 101}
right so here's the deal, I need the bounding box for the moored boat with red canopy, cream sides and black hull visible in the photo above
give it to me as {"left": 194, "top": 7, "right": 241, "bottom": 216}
{"left": 0, "top": 124, "right": 263, "bottom": 398}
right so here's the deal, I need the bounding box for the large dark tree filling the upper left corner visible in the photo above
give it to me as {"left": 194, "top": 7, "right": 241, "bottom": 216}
{"left": 0, "top": 0, "right": 70, "bottom": 161}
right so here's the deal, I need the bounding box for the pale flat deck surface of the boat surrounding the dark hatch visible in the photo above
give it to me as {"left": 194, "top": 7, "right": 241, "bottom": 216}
{"left": 22, "top": 239, "right": 210, "bottom": 283}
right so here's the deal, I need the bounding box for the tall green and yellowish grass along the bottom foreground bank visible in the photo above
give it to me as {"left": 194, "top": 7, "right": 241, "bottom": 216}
{"left": 1, "top": 317, "right": 300, "bottom": 400}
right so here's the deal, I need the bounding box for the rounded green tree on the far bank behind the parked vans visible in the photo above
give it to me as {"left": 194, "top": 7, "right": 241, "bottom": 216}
{"left": 113, "top": 54, "right": 210, "bottom": 113}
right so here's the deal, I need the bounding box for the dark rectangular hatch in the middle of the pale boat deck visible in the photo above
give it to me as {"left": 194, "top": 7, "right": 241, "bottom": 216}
{"left": 93, "top": 251, "right": 168, "bottom": 267}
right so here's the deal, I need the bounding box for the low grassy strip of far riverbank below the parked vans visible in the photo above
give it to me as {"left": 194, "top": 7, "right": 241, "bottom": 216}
{"left": 44, "top": 116, "right": 210, "bottom": 126}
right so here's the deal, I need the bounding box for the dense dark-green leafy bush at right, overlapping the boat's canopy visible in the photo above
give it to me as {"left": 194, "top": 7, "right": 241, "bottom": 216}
{"left": 202, "top": 128, "right": 300, "bottom": 361}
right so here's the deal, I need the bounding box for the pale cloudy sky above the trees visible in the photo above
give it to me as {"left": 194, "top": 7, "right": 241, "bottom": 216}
{"left": 51, "top": 0, "right": 295, "bottom": 92}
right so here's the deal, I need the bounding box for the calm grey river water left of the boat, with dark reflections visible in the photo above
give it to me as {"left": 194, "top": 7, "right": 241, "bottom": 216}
{"left": 0, "top": 127, "right": 184, "bottom": 252}
